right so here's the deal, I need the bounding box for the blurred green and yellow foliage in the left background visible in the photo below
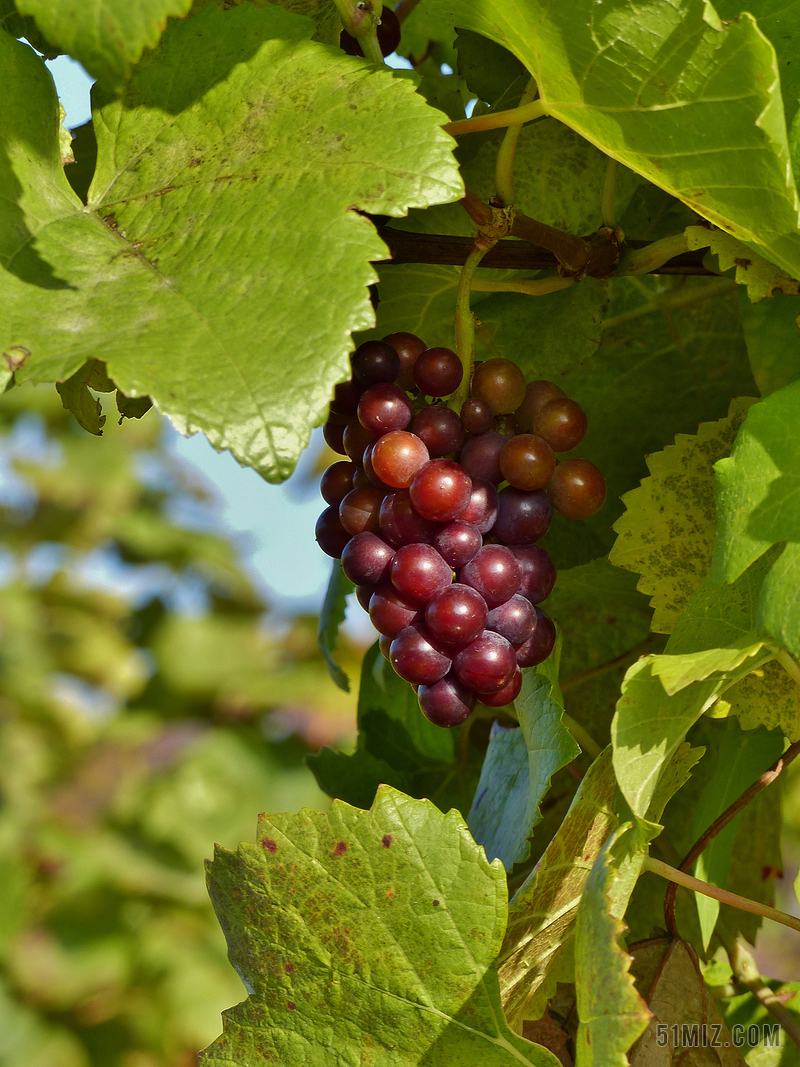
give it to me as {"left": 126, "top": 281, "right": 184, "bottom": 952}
{"left": 0, "top": 386, "right": 364, "bottom": 1067}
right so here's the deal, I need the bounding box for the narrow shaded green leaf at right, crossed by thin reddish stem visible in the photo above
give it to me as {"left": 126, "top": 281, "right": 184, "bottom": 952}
{"left": 692, "top": 721, "right": 783, "bottom": 950}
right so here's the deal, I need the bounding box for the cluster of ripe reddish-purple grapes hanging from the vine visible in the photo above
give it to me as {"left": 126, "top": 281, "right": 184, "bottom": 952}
{"left": 317, "top": 333, "right": 606, "bottom": 727}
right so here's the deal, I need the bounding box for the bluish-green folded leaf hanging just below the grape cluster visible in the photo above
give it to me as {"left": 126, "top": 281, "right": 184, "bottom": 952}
{"left": 467, "top": 640, "right": 580, "bottom": 871}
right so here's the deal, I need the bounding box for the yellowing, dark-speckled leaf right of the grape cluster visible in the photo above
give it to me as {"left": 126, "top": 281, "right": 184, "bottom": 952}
{"left": 609, "top": 397, "right": 755, "bottom": 634}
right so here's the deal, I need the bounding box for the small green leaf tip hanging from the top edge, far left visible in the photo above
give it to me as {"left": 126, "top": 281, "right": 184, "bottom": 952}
{"left": 16, "top": 0, "right": 192, "bottom": 89}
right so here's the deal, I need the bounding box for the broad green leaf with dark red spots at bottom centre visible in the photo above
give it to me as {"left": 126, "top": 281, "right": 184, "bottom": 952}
{"left": 203, "top": 786, "right": 558, "bottom": 1067}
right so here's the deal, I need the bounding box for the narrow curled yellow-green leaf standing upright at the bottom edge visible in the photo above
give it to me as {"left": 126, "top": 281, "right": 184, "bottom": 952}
{"left": 575, "top": 828, "right": 651, "bottom": 1067}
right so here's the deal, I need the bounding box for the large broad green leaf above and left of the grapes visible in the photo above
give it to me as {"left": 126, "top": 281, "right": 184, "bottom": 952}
{"left": 0, "top": 4, "right": 461, "bottom": 480}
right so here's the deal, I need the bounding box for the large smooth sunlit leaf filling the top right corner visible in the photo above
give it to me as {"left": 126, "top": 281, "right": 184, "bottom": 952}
{"left": 434, "top": 0, "right": 800, "bottom": 274}
